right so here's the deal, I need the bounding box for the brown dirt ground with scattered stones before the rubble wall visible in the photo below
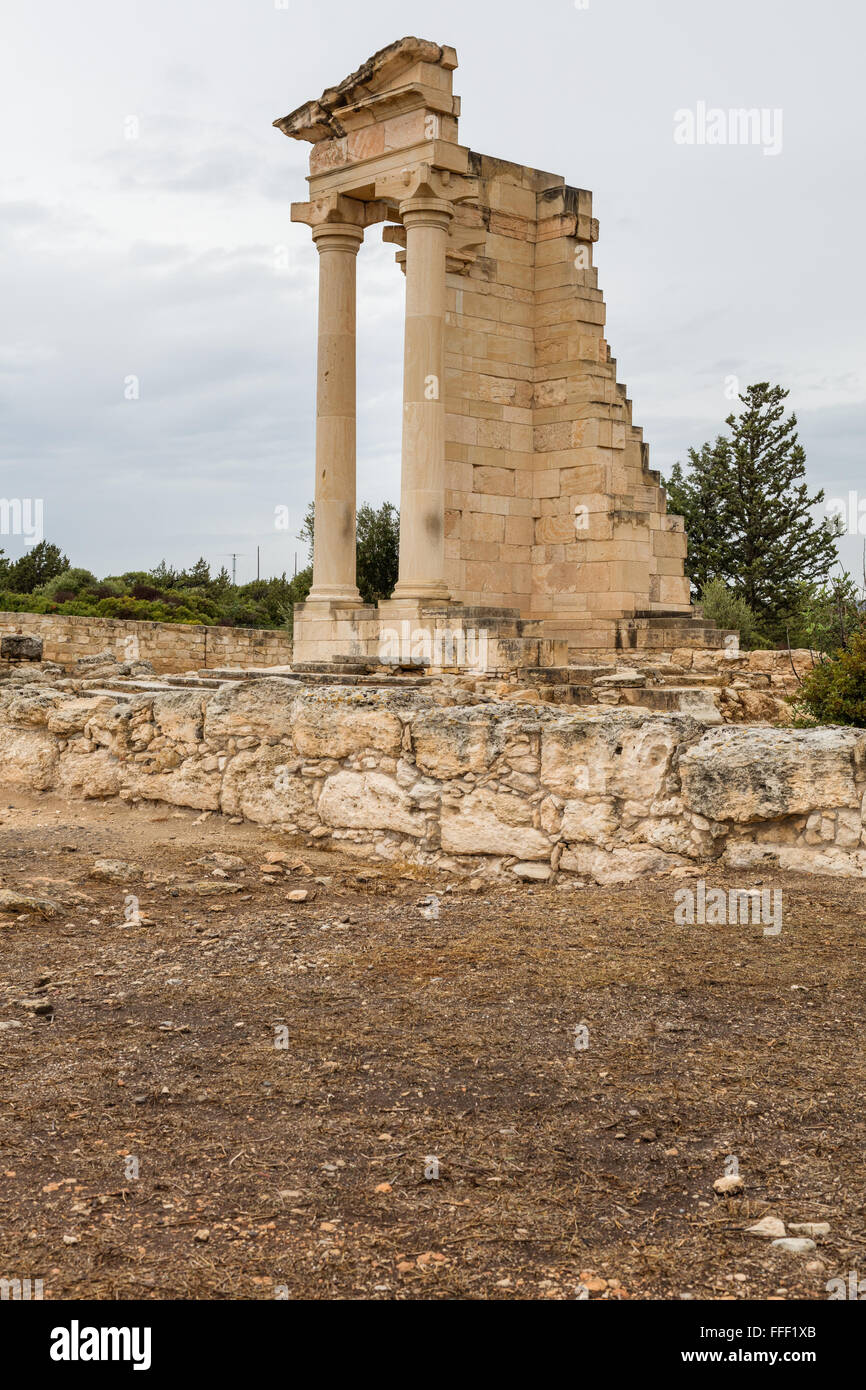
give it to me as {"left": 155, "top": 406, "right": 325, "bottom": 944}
{"left": 0, "top": 791, "right": 866, "bottom": 1300}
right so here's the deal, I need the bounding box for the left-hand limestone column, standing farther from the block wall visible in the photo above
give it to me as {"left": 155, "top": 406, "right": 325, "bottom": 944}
{"left": 307, "top": 221, "right": 364, "bottom": 603}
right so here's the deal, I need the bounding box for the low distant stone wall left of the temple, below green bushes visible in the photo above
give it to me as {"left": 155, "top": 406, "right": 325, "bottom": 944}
{"left": 0, "top": 613, "right": 292, "bottom": 674}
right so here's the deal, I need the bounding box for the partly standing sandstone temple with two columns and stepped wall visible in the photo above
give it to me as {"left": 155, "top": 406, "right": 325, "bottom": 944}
{"left": 274, "top": 38, "right": 721, "bottom": 666}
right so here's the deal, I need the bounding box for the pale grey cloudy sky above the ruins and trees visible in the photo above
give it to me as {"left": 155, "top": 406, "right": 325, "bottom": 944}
{"left": 0, "top": 0, "right": 866, "bottom": 581}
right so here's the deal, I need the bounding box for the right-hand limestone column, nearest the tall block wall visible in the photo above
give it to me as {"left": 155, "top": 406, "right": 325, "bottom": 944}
{"left": 393, "top": 197, "right": 453, "bottom": 602}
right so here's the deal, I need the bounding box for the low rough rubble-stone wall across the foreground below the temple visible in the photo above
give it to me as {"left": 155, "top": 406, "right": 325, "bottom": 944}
{"left": 0, "top": 678, "right": 866, "bottom": 883}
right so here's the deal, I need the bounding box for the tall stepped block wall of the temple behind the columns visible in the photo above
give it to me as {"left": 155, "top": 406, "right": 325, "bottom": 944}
{"left": 445, "top": 161, "right": 689, "bottom": 641}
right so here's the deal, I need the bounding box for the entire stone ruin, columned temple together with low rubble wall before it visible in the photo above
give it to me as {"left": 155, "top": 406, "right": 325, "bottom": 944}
{"left": 0, "top": 39, "right": 850, "bottom": 887}
